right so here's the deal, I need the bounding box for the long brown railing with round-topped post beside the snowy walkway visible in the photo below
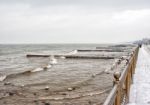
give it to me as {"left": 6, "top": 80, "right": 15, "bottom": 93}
{"left": 103, "top": 46, "right": 139, "bottom": 105}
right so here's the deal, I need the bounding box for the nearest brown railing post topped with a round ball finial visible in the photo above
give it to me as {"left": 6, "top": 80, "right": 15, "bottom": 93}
{"left": 114, "top": 72, "right": 121, "bottom": 105}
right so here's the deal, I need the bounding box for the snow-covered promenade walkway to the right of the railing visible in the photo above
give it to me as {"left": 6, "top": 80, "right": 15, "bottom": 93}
{"left": 128, "top": 47, "right": 150, "bottom": 105}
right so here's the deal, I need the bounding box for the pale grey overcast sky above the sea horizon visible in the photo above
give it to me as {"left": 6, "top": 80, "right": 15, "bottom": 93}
{"left": 0, "top": 0, "right": 150, "bottom": 43}
